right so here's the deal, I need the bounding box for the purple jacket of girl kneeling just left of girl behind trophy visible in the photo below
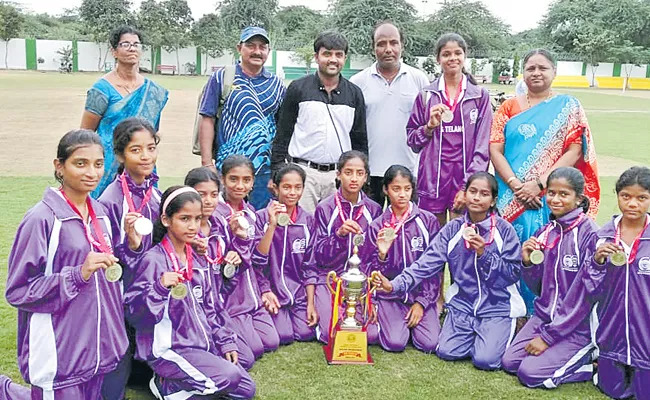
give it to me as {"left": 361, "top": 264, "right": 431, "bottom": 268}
{"left": 252, "top": 206, "right": 314, "bottom": 307}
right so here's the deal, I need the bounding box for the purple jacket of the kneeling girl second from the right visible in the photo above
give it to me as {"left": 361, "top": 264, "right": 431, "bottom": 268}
{"left": 522, "top": 209, "right": 598, "bottom": 346}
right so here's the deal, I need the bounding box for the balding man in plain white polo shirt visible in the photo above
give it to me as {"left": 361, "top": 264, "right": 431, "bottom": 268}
{"left": 350, "top": 21, "right": 429, "bottom": 205}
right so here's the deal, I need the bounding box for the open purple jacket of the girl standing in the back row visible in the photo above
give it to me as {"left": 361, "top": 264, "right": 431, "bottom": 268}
{"left": 406, "top": 78, "right": 492, "bottom": 205}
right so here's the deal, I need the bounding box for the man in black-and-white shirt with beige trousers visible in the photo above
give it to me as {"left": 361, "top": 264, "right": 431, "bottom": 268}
{"left": 271, "top": 31, "right": 368, "bottom": 212}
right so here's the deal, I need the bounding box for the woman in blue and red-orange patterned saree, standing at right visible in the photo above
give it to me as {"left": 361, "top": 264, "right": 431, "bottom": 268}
{"left": 490, "top": 49, "right": 600, "bottom": 314}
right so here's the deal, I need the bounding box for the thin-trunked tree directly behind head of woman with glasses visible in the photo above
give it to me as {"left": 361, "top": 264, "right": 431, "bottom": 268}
{"left": 79, "top": 0, "right": 133, "bottom": 70}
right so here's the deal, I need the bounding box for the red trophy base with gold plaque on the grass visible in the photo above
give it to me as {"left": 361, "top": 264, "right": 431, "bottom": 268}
{"left": 323, "top": 327, "right": 375, "bottom": 365}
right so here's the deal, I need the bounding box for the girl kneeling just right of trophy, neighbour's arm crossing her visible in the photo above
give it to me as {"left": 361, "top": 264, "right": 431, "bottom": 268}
{"left": 368, "top": 165, "right": 442, "bottom": 353}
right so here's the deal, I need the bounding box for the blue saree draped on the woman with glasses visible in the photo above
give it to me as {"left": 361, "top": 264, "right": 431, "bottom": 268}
{"left": 91, "top": 79, "right": 168, "bottom": 199}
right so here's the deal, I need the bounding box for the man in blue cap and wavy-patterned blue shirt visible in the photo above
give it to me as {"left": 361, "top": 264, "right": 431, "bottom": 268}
{"left": 199, "top": 26, "right": 285, "bottom": 209}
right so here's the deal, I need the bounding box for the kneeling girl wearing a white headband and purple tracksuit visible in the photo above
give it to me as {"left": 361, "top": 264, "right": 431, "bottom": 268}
{"left": 125, "top": 186, "right": 255, "bottom": 399}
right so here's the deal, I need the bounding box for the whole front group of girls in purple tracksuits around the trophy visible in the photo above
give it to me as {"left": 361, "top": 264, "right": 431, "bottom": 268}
{"left": 5, "top": 115, "right": 650, "bottom": 399}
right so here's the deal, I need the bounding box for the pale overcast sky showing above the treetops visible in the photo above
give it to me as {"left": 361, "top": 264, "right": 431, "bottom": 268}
{"left": 14, "top": 0, "right": 551, "bottom": 33}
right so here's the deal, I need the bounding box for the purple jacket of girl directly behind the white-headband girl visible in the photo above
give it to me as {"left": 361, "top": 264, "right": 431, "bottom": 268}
{"left": 98, "top": 174, "right": 161, "bottom": 288}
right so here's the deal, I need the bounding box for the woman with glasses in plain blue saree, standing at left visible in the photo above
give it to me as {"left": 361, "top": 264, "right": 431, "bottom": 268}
{"left": 81, "top": 26, "right": 168, "bottom": 198}
